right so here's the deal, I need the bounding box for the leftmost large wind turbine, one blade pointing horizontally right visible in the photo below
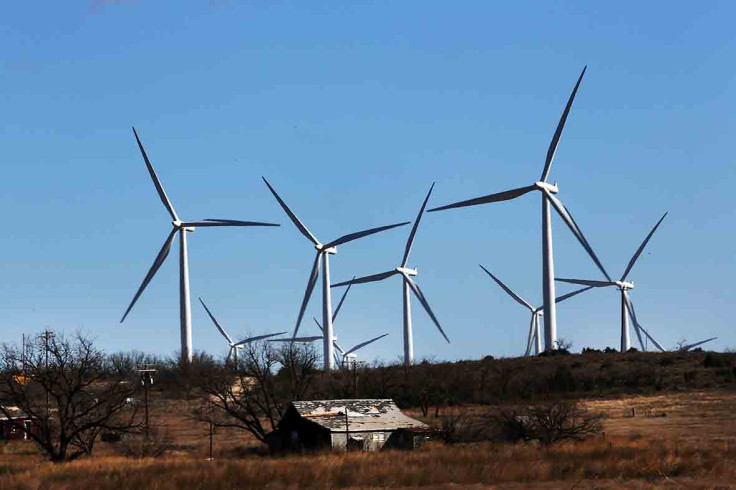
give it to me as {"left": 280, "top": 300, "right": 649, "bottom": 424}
{"left": 120, "top": 128, "right": 279, "bottom": 362}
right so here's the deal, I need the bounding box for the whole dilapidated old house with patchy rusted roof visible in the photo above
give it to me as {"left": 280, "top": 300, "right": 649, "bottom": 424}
{"left": 268, "top": 400, "right": 432, "bottom": 451}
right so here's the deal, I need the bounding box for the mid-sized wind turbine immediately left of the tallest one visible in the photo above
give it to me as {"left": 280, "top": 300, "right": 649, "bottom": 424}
{"left": 332, "top": 183, "right": 450, "bottom": 366}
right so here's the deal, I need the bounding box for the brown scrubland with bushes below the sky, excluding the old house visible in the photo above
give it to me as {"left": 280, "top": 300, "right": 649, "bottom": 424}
{"left": 0, "top": 337, "right": 736, "bottom": 489}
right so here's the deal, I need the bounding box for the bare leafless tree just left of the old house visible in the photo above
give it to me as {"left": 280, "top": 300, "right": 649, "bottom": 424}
{"left": 193, "top": 342, "right": 318, "bottom": 443}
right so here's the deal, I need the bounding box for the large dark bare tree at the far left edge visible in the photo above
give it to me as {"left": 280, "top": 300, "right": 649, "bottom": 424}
{"left": 0, "top": 332, "right": 137, "bottom": 463}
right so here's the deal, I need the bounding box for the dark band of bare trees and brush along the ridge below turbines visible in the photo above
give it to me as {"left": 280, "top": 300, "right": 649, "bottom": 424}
{"left": 0, "top": 332, "right": 736, "bottom": 462}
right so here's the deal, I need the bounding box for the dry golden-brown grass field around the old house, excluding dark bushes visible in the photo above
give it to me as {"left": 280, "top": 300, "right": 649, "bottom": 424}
{"left": 0, "top": 392, "right": 736, "bottom": 490}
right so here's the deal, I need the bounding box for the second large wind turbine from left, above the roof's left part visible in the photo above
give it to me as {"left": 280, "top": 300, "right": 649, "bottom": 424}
{"left": 261, "top": 177, "right": 409, "bottom": 370}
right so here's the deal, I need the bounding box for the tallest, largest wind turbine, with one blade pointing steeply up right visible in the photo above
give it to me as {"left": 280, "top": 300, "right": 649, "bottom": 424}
{"left": 427, "top": 67, "right": 611, "bottom": 350}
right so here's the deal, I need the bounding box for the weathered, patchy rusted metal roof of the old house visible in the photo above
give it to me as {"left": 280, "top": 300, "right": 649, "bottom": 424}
{"left": 291, "top": 399, "right": 428, "bottom": 432}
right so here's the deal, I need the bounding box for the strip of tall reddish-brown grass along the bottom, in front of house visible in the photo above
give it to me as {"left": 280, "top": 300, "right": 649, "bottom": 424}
{"left": 0, "top": 438, "right": 736, "bottom": 490}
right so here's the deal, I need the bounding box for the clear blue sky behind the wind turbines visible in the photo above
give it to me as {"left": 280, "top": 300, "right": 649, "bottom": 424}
{"left": 0, "top": 0, "right": 736, "bottom": 360}
